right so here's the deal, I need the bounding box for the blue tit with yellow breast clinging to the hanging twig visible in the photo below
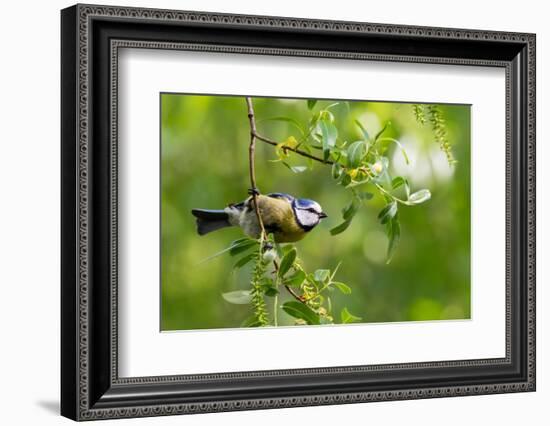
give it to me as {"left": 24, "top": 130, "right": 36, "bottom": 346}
{"left": 191, "top": 193, "right": 327, "bottom": 243}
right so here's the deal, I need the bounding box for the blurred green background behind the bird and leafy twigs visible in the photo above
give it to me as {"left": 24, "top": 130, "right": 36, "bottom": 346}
{"left": 161, "top": 93, "right": 470, "bottom": 330}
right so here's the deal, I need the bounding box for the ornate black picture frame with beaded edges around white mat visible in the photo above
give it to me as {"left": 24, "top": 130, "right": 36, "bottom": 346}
{"left": 61, "top": 5, "right": 535, "bottom": 420}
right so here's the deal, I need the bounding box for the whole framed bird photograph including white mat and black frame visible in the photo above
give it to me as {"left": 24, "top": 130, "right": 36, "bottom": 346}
{"left": 61, "top": 5, "right": 535, "bottom": 420}
